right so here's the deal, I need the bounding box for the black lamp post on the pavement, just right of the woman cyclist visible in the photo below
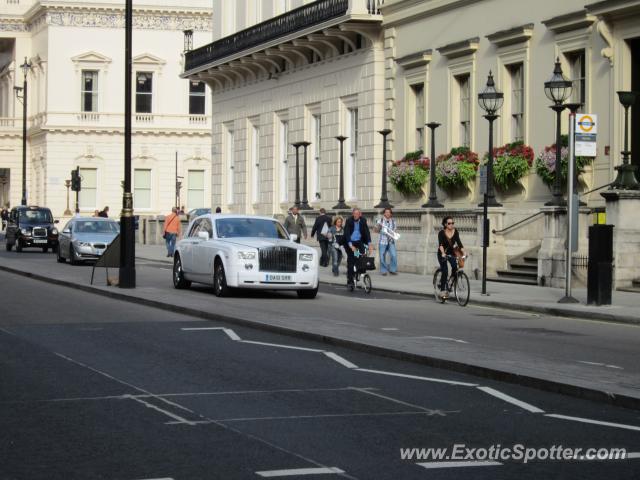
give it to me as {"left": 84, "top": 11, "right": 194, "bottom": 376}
{"left": 478, "top": 71, "right": 504, "bottom": 295}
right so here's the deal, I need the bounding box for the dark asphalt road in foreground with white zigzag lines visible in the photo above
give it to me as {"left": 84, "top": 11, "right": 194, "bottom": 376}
{"left": 0, "top": 272, "right": 640, "bottom": 480}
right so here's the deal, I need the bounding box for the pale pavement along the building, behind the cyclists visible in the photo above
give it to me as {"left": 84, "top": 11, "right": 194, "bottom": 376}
{"left": 136, "top": 245, "right": 640, "bottom": 324}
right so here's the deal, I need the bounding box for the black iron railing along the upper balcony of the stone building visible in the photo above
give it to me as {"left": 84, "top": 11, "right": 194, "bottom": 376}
{"left": 185, "top": 0, "right": 348, "bottom": 71}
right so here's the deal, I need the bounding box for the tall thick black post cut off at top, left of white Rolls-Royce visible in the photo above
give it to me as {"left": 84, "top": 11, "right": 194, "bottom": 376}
{"left": 118, "top": 0, "right": 136, "bottom": 288}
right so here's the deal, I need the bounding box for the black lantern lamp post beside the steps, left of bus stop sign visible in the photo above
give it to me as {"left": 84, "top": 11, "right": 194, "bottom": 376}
{"left": 544, "top": 58, "right": 573, "bottom": 207}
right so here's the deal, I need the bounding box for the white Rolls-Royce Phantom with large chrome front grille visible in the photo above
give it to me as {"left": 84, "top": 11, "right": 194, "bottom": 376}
{"left": 173, "top": 214, "right": 318, "bottom": 298}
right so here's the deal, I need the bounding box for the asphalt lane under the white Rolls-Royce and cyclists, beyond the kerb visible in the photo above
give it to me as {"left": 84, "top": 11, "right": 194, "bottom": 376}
{"left": 0, "top": 246, "right": 640, "bottom": 398}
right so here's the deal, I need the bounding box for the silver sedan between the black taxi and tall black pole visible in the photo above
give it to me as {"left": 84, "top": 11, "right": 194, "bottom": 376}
{"left": 58, "top": 217, "right": 120, "bottom": 265}
